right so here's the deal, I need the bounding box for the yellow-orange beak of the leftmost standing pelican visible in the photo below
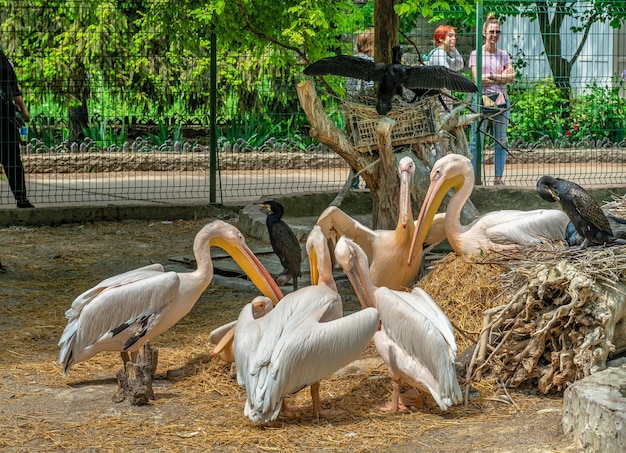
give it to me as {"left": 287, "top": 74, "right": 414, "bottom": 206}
{"left": 210, "top": 237, "right": 283, "bottom": 304}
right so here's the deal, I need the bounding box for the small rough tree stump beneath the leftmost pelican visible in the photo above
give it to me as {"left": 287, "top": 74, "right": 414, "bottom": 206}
{"left": 113, "top": 342, "right": 159, "bottom": 406}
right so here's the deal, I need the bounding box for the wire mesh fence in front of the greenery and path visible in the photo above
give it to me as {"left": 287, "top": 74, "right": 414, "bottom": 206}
{"left": 0, "top": 0, "right": 626, "bottom": 207}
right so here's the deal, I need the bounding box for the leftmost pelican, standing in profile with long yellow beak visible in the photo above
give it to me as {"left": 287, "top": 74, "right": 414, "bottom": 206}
{"left": 59, "top": 220, "right": 282, "bottom": 374}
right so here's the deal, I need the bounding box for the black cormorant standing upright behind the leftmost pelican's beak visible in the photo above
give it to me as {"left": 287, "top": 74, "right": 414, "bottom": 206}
{"left": 261, "top": 200, "right": 302, "bottom": 291}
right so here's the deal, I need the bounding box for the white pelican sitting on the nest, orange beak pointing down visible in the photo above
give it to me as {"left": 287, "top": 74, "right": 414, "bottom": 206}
{"left": 409, "top": 154, "right": 569, "bottom": 257}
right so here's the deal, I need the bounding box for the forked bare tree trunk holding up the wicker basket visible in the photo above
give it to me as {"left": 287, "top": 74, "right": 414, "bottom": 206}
{"left": 297, "top": 80, "right": 478, "bottom": 229}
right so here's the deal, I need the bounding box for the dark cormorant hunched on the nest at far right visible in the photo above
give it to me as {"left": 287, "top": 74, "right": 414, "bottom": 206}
{"left": 537, "top": 176, "right": 626, "bottom": 249}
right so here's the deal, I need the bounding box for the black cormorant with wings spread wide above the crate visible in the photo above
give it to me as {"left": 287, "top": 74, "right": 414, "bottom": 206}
{"left": 304, "top": 50, "right": 477, "bottom": 115}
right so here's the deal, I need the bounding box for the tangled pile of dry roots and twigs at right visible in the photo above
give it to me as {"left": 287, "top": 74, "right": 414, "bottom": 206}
{"left": 469, "top": 247, "right": 626, "bottom": 393}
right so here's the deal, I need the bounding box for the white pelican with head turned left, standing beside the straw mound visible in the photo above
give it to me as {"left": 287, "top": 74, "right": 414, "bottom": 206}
{"left": 335, "top": 236, "right": 463, "bottom": 412}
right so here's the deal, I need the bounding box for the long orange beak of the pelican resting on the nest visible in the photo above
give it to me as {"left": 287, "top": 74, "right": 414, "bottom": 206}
{"left": 408, "top": 170, "right": 465, "bottom": 265}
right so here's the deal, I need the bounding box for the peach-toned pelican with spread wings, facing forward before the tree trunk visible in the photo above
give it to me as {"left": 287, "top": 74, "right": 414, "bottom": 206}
{"left": 317, "top": 156, "right": 446, "bottom": 289}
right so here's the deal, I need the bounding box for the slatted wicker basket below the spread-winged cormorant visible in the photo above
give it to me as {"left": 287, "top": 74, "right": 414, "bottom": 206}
{"left": 343, "top": 96, "right": 441, "bottom": 152}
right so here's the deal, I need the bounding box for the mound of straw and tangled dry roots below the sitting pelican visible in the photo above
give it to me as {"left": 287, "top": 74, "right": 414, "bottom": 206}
{"left": 420, "top": 244, "right": 626, "bottom": 393}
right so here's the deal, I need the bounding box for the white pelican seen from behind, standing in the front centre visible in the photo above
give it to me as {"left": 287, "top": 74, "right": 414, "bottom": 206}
{"left": 235, "top": 227, "right": 378, "bottom": 423}
